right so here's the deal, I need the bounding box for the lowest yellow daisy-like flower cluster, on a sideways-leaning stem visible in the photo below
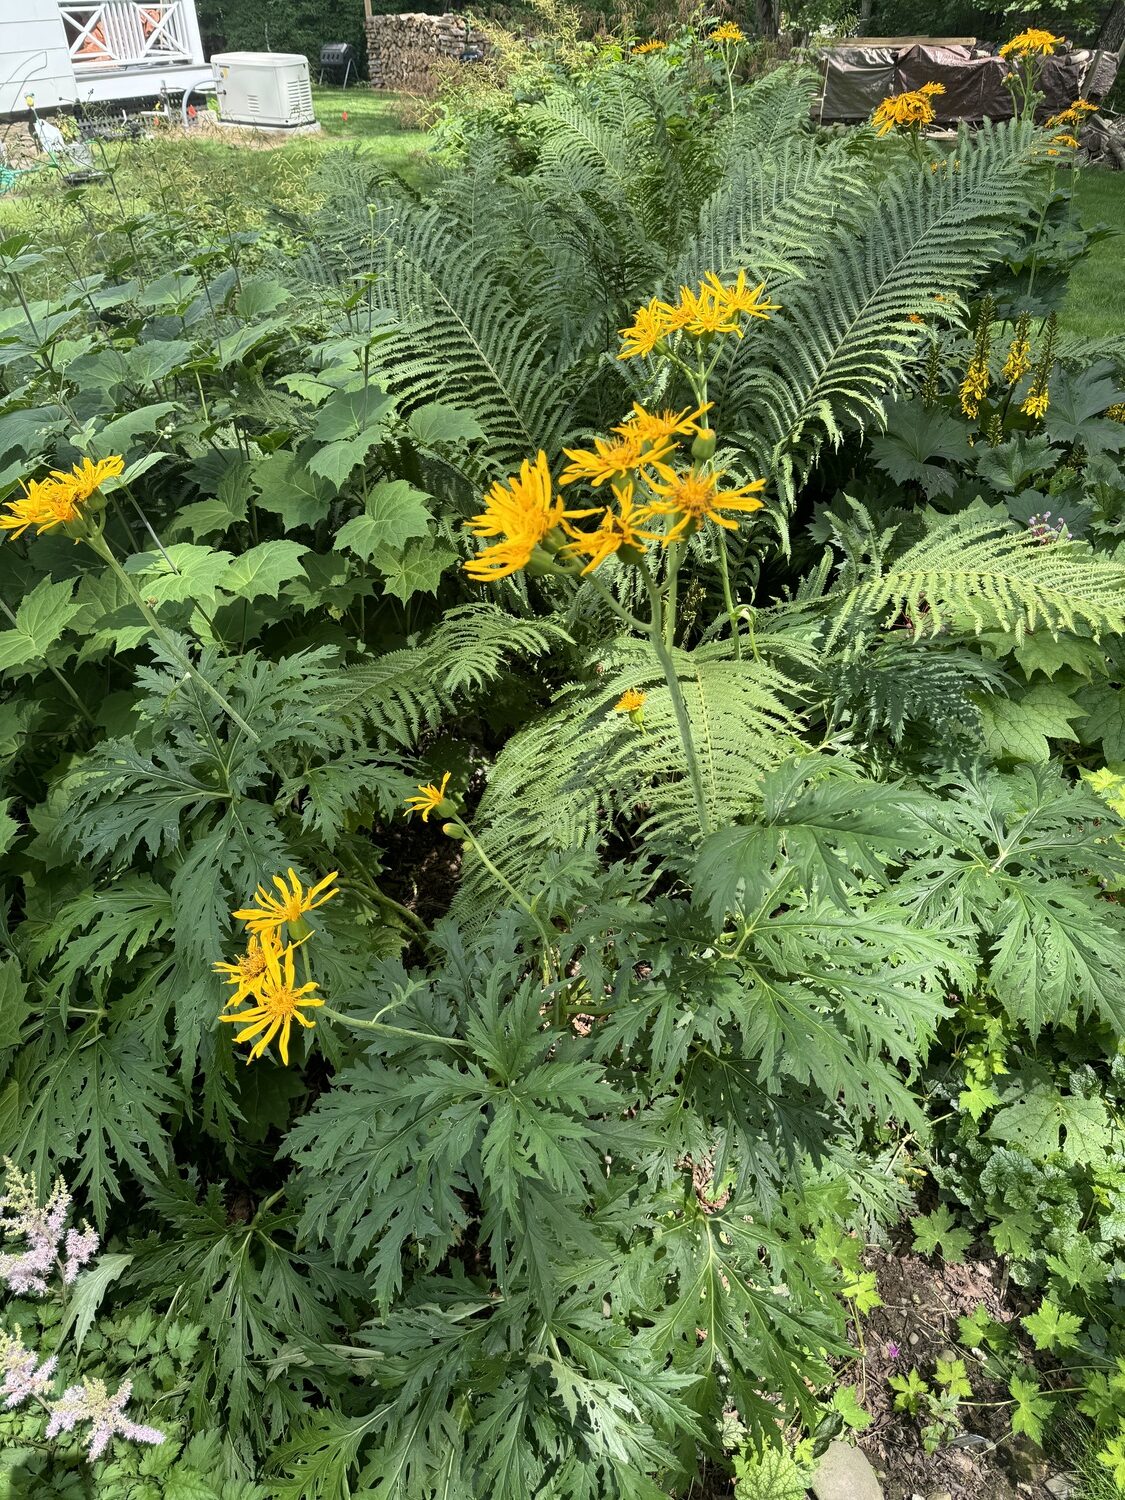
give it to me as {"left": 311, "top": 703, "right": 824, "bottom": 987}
{"left": 215, "top": 870, "right": 338, "bottom": 1067}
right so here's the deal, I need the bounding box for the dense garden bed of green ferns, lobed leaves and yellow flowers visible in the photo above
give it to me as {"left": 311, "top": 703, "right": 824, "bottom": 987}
{"left": 0, "top": 26, "right": 1125, "bottom": 1500}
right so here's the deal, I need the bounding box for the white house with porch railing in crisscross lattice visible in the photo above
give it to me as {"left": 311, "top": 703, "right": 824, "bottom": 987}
{"left": 0, "top": 0, "right": 212, "bottom": 116}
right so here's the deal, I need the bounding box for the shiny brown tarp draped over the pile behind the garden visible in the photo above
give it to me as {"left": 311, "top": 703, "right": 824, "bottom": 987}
{"left": 818, "top": 42, "right": 1116, "bottom": 125}
